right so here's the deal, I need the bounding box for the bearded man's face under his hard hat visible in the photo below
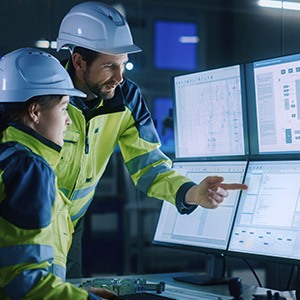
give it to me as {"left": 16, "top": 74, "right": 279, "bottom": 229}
{"left": 82, "top": 54, "right": 128, "bottom": 99}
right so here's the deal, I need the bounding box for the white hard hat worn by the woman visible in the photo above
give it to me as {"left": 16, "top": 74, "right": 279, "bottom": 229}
{"left": 0, "top": 48, "right": 86, "bottom": 102}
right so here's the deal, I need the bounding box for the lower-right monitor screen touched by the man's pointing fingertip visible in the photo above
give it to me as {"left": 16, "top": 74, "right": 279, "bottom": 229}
{"left": 228, "top": 160, "right": 300, "bottom": 262}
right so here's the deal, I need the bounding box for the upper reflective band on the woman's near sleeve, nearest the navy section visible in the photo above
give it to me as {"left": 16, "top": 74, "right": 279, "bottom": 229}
{"left": 0, "top": 244, "right": 54, "bottom": 268}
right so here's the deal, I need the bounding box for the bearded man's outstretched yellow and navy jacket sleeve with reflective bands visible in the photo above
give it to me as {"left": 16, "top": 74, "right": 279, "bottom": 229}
{"left": 119, "top": 81, "right": 196, "bottom": 214}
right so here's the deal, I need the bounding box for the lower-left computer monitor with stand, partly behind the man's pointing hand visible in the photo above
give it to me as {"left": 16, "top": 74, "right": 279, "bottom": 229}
{"left": 153, "top": 161, "right": 247, "bottom": 285}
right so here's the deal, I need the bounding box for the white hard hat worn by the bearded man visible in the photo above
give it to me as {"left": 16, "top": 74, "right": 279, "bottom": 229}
{"left": 57, "top": 1, "right": 141, "bottom": 55}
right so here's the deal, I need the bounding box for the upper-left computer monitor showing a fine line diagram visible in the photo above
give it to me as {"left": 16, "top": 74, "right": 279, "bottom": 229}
{"left": 172, "top": 65, "right": 248, "bottom": 160}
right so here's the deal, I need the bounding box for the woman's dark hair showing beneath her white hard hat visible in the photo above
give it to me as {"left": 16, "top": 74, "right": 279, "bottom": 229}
{"left": 0, "top": 95, "right": 63, "bottom": 131}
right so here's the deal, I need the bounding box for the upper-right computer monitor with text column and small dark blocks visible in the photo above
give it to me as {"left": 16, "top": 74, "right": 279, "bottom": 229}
{"left": 245, "top": 54, "right": 300, "bottom": 160}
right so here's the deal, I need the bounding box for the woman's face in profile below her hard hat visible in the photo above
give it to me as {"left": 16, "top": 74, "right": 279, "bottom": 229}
{"left": 34, "top": 96, "right": 71, "bottom": 147}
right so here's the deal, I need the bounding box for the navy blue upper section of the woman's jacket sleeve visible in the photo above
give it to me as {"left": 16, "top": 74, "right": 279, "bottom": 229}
{"left": 0, "top": 156, "right": 55, "bottom": 229}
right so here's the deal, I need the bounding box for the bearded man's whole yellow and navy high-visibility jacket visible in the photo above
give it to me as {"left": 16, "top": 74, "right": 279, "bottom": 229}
{"left": 56, "top": 79, "right": 195, "bottom": 225}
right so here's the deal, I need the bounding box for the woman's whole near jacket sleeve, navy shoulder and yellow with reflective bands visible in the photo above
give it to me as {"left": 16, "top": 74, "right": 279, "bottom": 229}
{"left": 0, "top": 157, "right": 99, "bottom": 299}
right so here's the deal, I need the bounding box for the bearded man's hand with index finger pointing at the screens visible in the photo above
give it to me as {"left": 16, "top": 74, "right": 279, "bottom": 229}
{"left": 185, "top": 176, "right": 248, "bottom": 208}
